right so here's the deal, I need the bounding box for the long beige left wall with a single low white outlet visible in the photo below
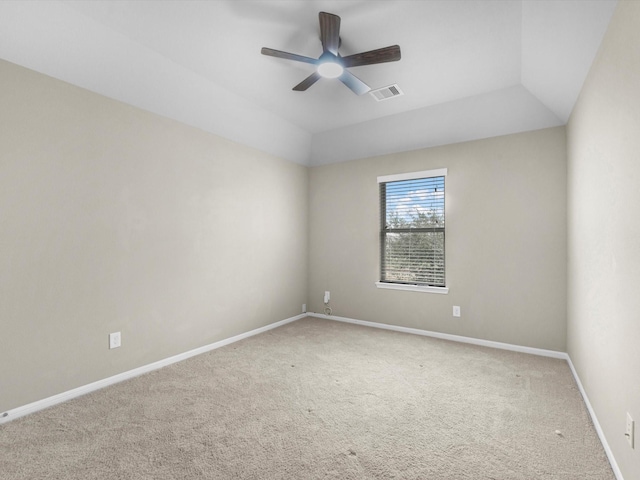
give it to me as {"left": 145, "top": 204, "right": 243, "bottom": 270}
{"left": 0, "top": 61, "right": 308, "bottom": 412}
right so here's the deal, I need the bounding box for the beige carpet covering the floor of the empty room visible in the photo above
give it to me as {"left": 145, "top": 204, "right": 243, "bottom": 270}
{"left": 0, "top": 318, "right": 614, "bottom": 480}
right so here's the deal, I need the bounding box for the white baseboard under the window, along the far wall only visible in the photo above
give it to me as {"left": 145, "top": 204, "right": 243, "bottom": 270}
{"left": 308, "top": 313, "right": 569, "bottom": 360}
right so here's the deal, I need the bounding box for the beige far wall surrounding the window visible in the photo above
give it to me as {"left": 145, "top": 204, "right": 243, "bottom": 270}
{"left": 308, "top": 127, "right": 566, "bottom": 351}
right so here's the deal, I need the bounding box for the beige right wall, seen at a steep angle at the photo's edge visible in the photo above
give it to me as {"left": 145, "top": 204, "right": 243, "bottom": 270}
{"left": 567, "top": 1, "right": 640, "bottom": 479}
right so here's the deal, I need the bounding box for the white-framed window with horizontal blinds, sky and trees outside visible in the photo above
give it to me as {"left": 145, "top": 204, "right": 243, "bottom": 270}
{"left": 376, "top": 169, "right": 448, "bottom": 293}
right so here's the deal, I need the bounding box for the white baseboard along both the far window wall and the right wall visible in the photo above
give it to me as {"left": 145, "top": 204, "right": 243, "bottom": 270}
{"left": 308, "top": 313, "right": 624, "bottom": 480}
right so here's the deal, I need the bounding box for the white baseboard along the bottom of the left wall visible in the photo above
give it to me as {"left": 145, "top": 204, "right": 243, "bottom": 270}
{"left": 0, "top": 314, "right": 307, "bottom": 425}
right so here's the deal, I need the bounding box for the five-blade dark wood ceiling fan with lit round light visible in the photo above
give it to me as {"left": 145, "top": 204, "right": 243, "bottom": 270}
{"left": 261, "top": 12, "right": 400, "bottom": 95}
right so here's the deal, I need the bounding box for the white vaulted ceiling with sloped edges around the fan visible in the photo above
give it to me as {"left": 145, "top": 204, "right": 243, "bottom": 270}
{"left": 0, "top": 0, "right": 616, "bottom": 165}
